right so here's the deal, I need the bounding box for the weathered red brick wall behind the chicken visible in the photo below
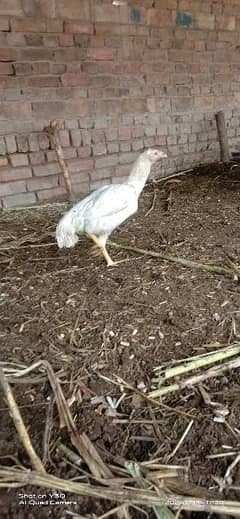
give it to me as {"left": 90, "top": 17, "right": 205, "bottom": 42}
{"left": 0, "top": 0, "right": 240, "bottom": 207}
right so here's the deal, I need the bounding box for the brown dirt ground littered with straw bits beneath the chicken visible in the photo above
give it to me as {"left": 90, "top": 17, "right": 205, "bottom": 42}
{"left": 0, "top": 165, "right": 240, "bottom": 519}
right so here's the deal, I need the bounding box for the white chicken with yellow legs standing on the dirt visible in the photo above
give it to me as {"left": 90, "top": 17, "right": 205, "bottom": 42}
{"left": 56, "top": 148, "right": 167, "bottom": 266}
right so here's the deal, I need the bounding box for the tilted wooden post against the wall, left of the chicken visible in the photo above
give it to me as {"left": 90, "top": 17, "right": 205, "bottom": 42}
{"left": 45, "top": 121, "right": 75, "bottom": 201}
